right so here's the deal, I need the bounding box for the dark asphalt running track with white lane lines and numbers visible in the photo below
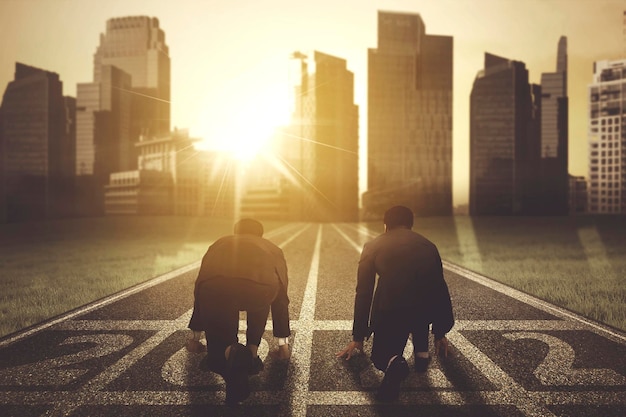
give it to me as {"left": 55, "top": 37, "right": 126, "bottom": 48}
{"left": 0, "top": 224, "right": 626, "bottom": 417}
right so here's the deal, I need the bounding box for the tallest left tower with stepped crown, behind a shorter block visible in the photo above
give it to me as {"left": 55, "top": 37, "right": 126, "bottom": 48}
{"left": 93, "top": 16, "right": 170, "bottom": 142}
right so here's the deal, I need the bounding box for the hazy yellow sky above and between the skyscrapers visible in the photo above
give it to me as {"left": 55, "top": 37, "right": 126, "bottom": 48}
{"left": 0, "top": 0, "right": 626, "bottom": 204}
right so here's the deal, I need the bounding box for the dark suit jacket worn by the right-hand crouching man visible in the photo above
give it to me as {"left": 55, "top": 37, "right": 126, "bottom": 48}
{"left": 352, "top": 228, "right": 454, "bottom": 341}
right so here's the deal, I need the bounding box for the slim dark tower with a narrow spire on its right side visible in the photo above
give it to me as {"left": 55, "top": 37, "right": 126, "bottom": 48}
{"left": 535, "top": 36, "right": 569, "bottom": 215}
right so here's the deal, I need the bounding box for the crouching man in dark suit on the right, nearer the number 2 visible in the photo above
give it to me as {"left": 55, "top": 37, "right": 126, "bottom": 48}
{"left": 337, "top": 206, "right": 454, "bottom": 401}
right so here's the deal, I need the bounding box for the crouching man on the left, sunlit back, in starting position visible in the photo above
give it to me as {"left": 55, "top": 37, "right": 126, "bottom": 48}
{"left": 187, "top": 219, "right": 291, "bottom": 405}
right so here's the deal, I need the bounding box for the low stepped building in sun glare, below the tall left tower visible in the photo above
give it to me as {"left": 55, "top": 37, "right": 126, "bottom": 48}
{"left": 104, "top": 130, "right": 238, "bottom": 218}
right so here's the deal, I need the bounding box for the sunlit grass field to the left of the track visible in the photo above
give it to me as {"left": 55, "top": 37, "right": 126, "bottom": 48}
{"left": 0, "top": 217, "right": 232, "bottom": 336}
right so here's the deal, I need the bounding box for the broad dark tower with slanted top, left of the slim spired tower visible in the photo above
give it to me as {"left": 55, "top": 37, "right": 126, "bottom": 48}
{"left": 469, "top": 53, "right": 539, "bottom": 215}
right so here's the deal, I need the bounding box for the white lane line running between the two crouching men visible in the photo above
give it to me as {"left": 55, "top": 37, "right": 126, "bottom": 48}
{"left": 280, "top": 225, "right": 322, "bottom": 417}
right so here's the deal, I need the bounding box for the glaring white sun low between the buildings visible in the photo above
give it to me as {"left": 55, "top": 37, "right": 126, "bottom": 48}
{"left": 197, "top": 84, "right": 289, "bottom": 162}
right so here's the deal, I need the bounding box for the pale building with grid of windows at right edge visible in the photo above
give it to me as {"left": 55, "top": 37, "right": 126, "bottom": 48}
{"left": 588, "top": 59, "right": 626, "bottom": 214}
